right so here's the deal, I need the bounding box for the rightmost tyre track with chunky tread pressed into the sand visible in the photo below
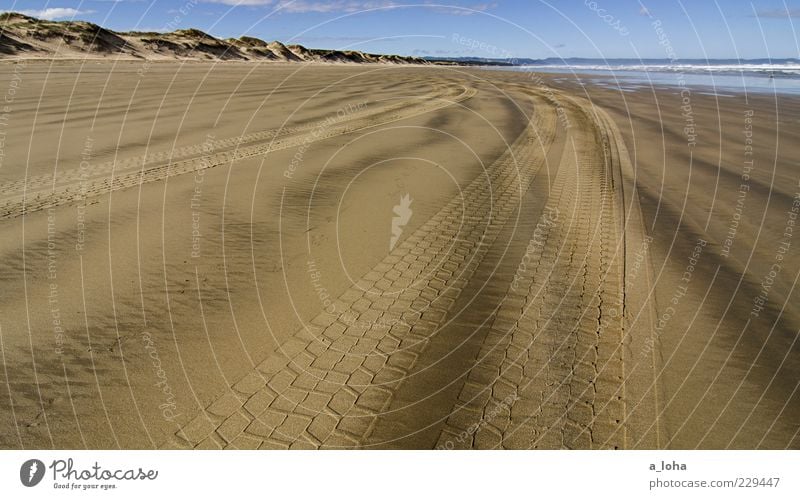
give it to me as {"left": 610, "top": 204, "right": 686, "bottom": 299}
{"left": 437, "top": 92, "right": 626, "bottom": 449}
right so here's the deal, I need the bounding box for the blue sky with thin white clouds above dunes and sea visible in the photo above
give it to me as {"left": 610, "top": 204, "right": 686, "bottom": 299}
{"left": 0, "top": 0, "right": 800, "bottom": 58}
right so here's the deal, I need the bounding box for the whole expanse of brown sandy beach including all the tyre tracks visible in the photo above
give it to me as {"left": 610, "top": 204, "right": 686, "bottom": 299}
{"left": 0, "top": 61, "right": 800, "bottom": 448}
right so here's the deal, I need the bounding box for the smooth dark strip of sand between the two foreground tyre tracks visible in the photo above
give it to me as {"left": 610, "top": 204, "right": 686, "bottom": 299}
{"left": 362, "top": 92, "right": 566, "bottom": 449}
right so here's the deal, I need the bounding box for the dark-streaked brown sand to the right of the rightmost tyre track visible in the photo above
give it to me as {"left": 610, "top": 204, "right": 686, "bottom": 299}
{"left": 590, "top": 79, "right": 800, "bottom": 449}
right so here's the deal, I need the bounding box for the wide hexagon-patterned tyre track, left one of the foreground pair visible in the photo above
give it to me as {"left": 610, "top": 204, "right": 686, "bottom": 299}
{"left": 165, "top": 92, "right": 555, "bottom": 448}
